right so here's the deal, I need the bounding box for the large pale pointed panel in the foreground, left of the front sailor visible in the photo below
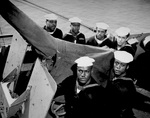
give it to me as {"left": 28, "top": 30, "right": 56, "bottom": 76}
{"left": 21, "top": 59, "right": 57, "bottom": 118}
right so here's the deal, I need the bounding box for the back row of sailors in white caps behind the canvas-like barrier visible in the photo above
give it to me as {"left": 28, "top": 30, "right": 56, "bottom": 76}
{"left": 44, "top": 14, "right": 138, "bottom": 55}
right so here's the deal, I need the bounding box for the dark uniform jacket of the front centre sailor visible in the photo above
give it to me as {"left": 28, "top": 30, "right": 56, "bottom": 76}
{"left": 55, "top": 76, "right": 108, "bottom": 118}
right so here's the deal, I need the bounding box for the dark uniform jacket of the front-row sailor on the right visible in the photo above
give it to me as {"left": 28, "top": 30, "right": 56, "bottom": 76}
{"left": 106, "top": 70, "right": 136, "bottom": 118}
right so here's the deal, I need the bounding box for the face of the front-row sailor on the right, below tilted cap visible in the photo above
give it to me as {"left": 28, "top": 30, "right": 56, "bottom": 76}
{"left": 113, "top": 59, "right": 128, "bottom": 76}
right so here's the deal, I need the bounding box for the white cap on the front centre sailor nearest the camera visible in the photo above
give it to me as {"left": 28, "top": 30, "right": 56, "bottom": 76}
{"left": 75, "top": 56, "right": 95, "bottom": 67}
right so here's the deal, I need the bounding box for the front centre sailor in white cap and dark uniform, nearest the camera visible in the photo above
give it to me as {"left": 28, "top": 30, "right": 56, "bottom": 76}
{"left": 52, "top": 56, "right": 107, "bottom": 118}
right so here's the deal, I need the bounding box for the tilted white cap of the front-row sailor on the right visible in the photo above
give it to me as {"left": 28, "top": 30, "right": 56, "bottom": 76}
{"left": 114, "top": 51, "right": 133, "bottom": 63}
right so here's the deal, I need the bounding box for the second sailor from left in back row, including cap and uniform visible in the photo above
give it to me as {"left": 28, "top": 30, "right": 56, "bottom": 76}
{"left": 63, "top": 17, "right": 86, "bottom": 44}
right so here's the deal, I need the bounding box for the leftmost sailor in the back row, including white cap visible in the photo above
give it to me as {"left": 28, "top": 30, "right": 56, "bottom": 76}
{"left": 43, "top": 14, "right": 63, "bottom": 39}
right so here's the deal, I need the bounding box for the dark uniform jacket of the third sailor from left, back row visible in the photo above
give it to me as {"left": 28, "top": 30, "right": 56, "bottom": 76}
{"left": 87, "top": 36, "right": 117, "bottom": 49}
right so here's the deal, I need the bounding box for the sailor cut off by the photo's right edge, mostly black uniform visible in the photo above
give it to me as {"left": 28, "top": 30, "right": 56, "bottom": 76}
{"left": 134, "top": 36, "right": 150, "bottom": 91}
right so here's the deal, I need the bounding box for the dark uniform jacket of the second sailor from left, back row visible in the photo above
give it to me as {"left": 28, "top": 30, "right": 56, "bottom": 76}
{"left": 63, "top": 31, "right": 86, "bottom": 44}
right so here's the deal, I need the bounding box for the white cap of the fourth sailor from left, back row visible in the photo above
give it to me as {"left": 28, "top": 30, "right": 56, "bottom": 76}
{"left": 115, "top": 27, "right": 130, "bottom": 37}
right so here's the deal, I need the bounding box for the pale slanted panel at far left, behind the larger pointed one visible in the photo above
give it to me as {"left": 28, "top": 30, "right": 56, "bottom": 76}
{"left": 3, "top": 33, "right": 27, "bottom": 78}
